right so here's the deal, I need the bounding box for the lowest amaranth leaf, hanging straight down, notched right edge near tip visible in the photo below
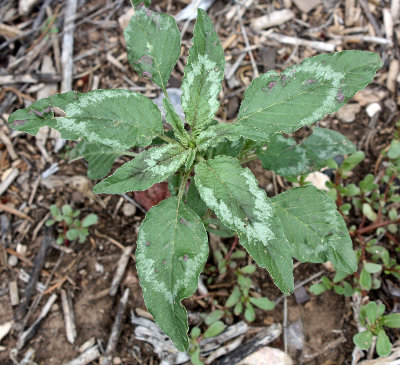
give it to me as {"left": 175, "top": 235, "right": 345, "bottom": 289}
{"left": 136, "top": 197, "right": 208, "bottom": 351}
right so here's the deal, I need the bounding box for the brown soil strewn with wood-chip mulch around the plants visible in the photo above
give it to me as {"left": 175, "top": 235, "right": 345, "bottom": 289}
{"left": 0, "top": 0, "right": 400, "bottom": 365}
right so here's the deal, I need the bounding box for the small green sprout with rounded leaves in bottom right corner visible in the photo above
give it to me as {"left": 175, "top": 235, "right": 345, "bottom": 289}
{"left": 353, "top": 302, "right": 400, "bottom": 356}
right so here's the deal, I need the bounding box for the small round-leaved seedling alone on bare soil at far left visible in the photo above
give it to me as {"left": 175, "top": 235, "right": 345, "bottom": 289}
{"left": 46, "top": 204, "right": 97, "bottom": 245}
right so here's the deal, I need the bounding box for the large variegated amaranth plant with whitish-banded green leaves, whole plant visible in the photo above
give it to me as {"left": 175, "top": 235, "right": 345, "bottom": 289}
{"left": 9, "top": 2, "right": 382, "bottom": 351}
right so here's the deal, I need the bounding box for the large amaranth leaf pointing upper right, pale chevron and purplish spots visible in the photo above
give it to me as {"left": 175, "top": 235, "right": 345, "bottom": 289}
{"left": 234, "top": 50, "right": 382, "bottom": 141}
